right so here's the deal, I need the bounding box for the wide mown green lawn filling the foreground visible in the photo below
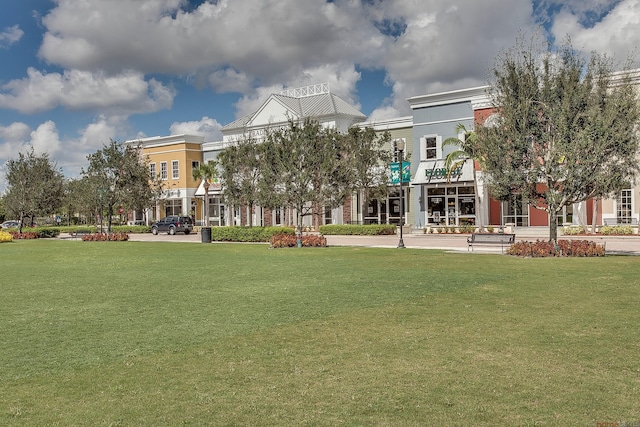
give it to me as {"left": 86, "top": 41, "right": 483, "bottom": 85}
{"left": 0, "top": 240, "right": 640, "bottom": 426}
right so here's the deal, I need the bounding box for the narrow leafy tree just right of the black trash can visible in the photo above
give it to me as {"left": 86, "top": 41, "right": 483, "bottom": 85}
{"left": 218, "top": 138, "right": 264, "bottom": 227}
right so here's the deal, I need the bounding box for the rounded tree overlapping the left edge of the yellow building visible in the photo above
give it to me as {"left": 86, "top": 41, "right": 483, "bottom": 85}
{"left": 82, "top": 140, "right": 154, "bottom": 233}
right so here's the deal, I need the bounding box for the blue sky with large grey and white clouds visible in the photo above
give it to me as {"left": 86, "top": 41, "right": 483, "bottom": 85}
{"left": 0, "top": 0, "right": 640, "bottom": 192}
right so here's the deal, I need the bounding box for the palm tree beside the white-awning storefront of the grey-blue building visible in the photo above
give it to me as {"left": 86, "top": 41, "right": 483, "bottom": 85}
{"left": 442, "top": 123, "right": 484, "bottom": 231}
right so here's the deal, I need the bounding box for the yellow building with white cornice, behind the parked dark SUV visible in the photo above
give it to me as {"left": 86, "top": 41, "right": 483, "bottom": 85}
{"left": 132, "top": 135, "right": 204, "bottom": 224}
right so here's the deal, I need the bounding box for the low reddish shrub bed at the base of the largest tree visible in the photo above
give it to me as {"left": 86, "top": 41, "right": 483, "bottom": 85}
{"left": 507, "top": 240, "right": 605, "bottom": 258}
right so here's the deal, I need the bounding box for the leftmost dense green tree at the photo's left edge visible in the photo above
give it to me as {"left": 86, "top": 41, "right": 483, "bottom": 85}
{"left": 4, "top": 147, "right": 64, "bottom": 232}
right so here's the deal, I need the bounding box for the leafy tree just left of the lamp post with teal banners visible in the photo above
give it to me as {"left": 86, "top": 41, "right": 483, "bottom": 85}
{"left": 343, "top": 127, "right": 391, "bottom": 227}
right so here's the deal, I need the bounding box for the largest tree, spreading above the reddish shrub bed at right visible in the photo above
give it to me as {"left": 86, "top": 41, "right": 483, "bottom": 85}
{"left": 476, "top": 42, "right": 639, "bottom": 241}
